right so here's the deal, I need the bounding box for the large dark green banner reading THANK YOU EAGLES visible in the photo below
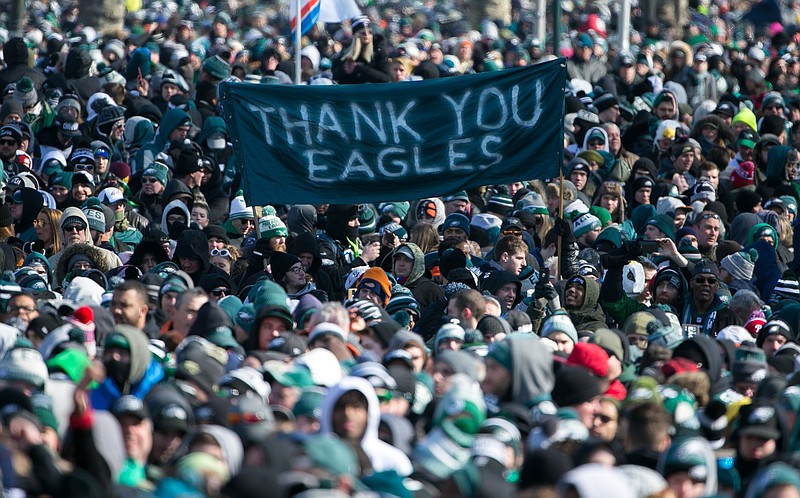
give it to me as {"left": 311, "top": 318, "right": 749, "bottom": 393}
{"left": 221, "top": 59, "right": 566, "bottom": 204}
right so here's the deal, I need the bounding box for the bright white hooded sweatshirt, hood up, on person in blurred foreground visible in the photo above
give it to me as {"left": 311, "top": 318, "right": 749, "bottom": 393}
{"left": 320, "top": 377, "right": 414, "bottom": 476}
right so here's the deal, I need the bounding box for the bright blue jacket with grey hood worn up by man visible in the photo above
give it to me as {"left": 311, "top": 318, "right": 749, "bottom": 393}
{"left": 90, "top": 325, "right": 164, "bottom": 410}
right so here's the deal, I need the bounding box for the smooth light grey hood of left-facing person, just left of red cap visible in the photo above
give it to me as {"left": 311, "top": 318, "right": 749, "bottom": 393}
{"left": 504, "top": 334, "right": 555, "bottom": 406}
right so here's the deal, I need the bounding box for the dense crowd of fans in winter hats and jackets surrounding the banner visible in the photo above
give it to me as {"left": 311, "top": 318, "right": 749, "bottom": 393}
{"left": 0, "top": 1, "right": 800, "bottom": 498}
